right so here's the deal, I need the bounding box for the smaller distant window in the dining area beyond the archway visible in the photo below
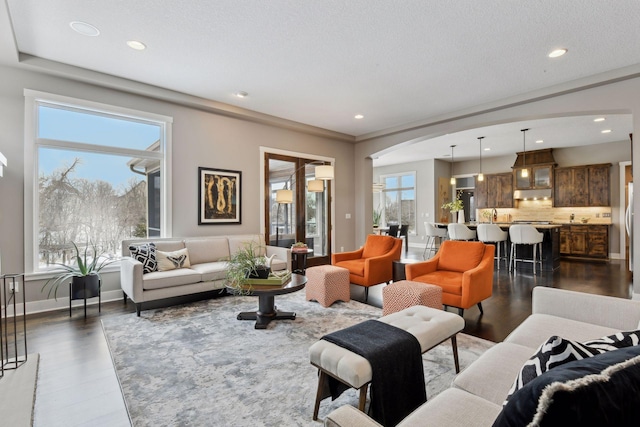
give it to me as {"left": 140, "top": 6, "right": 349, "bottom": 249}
{"left": 376, "top": 172, "right": 416, "bottom": 234}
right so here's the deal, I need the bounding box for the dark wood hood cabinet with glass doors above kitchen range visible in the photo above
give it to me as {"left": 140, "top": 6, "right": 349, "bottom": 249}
{"left": 513, "top": 148, "right": 555, "bottom": 190}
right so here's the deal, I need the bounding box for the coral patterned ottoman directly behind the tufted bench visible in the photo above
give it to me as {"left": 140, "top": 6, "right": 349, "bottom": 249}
{"left": 382, "top": 280, "right": 442, "bottom": 316}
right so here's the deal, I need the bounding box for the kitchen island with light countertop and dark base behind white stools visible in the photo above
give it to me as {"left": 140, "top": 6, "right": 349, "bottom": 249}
{"left": 436, "top": 222, "right": 562, "bottom": 271}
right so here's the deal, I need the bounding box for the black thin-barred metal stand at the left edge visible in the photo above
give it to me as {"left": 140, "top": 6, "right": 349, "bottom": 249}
{"left": 0, "top": 273, "right": 27, "bottom": 377}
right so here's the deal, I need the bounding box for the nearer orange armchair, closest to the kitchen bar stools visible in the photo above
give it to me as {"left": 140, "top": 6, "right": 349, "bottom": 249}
{"left": 405, "top": 240, "right": 495, "bottom": 316}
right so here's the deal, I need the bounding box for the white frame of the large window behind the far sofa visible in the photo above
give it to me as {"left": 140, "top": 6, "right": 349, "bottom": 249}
{"left": 24, "top": 89, "right": 173, "bottom": 276}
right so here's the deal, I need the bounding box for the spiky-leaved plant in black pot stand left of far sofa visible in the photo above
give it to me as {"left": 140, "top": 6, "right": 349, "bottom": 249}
{"left": 41, "top": 242, "right": 117, "bottom": 299}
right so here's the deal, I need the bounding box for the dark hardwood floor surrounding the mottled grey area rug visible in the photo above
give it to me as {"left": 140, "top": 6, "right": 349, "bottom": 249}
{"left": 22, "top": 248, "right": 632, "bottom": 427}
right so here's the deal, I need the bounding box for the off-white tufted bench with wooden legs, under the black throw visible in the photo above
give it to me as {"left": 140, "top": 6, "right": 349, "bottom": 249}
{"left": 309, "top": 305, "right": 464, "bottom": 420}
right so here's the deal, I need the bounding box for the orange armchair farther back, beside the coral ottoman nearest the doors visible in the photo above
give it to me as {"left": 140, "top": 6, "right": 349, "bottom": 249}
{"left": 331, "top": 234, "right": 402, "bottom": 302}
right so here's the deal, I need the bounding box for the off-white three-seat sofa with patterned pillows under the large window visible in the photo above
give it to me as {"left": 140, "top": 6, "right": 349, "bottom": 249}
{"left": 120, "top": 234, "right": 291, "bottom": 316}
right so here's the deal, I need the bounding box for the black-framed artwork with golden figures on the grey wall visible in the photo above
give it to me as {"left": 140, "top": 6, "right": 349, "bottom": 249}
{"left": 198, "top": 167, "right": 242, "bottom": 225}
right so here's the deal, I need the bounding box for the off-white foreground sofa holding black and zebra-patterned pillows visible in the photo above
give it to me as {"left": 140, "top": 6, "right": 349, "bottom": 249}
{"left": 325, "top": 287, "right": 640, "bottom": 427}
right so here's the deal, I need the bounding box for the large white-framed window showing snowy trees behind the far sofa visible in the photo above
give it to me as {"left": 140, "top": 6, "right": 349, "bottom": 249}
{"left": 25, "top": 91, "right": 171, "bottom": 271}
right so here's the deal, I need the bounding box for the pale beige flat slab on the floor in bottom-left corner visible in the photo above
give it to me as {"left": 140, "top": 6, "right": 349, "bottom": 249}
{"left": 0, "top": 353, "right": 40, "bottom": 426}
